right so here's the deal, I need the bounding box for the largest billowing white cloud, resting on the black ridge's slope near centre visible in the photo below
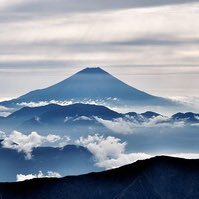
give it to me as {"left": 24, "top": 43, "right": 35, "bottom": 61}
{"left": 76, "top": 134, "right": 151, "bottom": 169}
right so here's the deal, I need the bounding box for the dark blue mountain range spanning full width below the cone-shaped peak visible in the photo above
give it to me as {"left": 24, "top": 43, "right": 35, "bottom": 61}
{"left": 0, "top": 104, "right": 199, "bottom": 134}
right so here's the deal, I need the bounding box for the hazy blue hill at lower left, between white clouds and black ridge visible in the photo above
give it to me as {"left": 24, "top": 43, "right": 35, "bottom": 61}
{"left": 0, "top": 145, "right": 99, "bottom": 182}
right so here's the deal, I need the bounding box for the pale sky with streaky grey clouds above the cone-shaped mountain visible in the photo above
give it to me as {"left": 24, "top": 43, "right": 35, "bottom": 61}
{"left": 0, "top": 0, "right": 199, "bottom": 100}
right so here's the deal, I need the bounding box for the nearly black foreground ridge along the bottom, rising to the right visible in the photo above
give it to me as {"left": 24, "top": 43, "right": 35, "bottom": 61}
{"left": 0, "top": 156, "right": 199, "bottom": 199}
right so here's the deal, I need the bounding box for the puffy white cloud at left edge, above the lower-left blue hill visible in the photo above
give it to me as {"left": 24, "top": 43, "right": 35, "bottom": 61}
{"left": 2, "top": 131, "right": 70, "bottom": 159}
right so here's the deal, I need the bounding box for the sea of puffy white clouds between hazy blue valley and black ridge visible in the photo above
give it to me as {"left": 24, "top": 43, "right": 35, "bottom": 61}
{"left": 0, "top": 131, "right": 199, "bottom": 181}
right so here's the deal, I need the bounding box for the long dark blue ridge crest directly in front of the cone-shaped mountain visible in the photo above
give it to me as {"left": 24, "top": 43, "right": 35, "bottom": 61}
{"left": 7, "top": 103, "right": 122, "bottom": 120}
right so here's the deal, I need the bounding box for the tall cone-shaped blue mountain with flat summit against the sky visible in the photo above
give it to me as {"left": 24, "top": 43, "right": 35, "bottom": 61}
{"left": 0, "top": 67, "right": 176, "bottom": 108}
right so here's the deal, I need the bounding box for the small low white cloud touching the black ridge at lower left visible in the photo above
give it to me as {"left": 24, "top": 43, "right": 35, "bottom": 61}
{"left": 16, "top": 171, "right": 61, "bottom": 182}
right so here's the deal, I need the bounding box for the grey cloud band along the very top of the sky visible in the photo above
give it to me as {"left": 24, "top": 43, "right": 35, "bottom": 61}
{"left": 4, "top": 0, "right": 199, "bottom": 14}
